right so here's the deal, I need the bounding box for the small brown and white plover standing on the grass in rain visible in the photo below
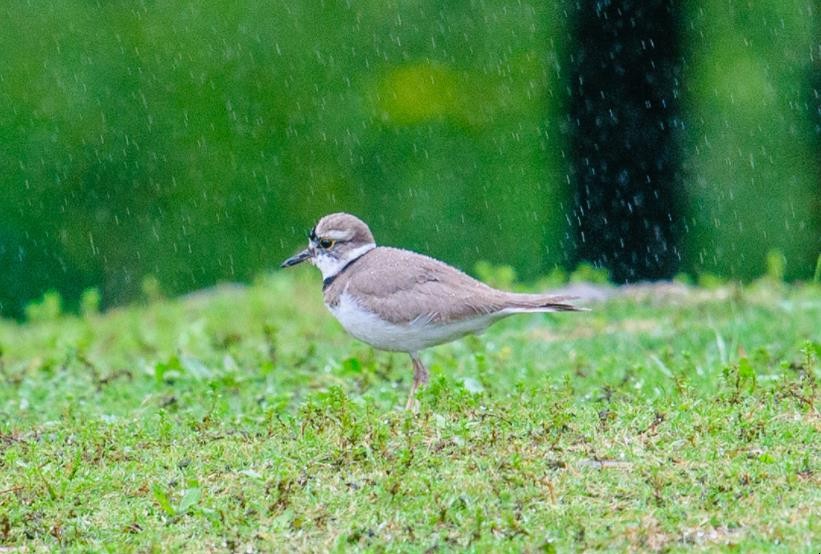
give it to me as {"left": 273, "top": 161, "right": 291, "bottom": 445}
{"left": 281, "top": 213, "right": 584, "bottom": 409}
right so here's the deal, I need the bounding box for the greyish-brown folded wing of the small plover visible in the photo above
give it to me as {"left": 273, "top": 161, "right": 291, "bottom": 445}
{"left": 334, "top": 247, "right": 506, "bottom": 323}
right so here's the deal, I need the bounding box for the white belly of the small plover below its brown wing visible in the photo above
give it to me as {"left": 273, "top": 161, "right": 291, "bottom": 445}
{"left": 328, "top": 293, "right": 499, "bottom": 352}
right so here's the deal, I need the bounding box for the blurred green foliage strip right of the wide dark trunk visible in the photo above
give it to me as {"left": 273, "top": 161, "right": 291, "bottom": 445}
{"left": 682, "top": 0, "right": 821, "bottom": 279}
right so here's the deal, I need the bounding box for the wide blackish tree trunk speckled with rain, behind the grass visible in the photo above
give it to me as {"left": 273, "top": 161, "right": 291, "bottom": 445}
{"left": 570, "top": 0, "right": 682, "bottom": 282}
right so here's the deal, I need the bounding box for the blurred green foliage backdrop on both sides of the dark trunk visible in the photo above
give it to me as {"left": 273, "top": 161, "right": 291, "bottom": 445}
{"left": 0, "top": 0, "right": 821, "bottom": 316}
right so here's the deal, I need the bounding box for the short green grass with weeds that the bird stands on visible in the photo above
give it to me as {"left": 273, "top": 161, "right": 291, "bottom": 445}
{"left": 0, "top": 271, "right": 821, "bottom": 552}
